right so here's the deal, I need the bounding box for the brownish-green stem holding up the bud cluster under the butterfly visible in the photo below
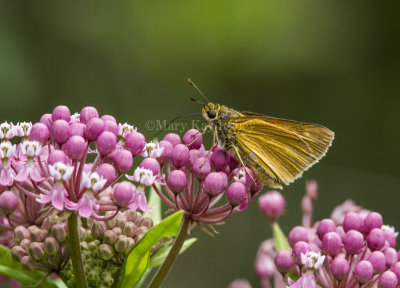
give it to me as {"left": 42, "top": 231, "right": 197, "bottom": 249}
{"left": 149, "top": 216, "right": 190, "bottom": 288}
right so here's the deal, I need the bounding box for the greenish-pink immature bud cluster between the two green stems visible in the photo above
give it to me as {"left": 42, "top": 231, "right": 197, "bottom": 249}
{"left": 62, "top": 210, "right": 153, "bottom": 288}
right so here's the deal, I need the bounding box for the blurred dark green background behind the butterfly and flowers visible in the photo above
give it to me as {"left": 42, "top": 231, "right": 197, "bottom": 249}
{"left": 0, "top": 0, "right": 400, "bottom": 287}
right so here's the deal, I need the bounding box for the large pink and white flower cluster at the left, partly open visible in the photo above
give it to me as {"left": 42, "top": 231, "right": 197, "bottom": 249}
{"left": 0, "top": 106, "right": 163, "bottom": 227}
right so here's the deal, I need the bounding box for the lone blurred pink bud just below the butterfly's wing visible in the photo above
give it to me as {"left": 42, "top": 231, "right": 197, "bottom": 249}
{"left": 258, "top": 191, "right": 285, "bottom": 222}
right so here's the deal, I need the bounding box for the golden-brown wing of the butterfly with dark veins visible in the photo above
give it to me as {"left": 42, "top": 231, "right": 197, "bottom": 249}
{"left": 231, "top": 115, "right": 334, "bottom": 187}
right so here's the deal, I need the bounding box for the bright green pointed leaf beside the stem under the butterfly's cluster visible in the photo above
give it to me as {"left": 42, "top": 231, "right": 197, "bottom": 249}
{"left": 118, "top": 211, "right": 183, "bottom": 288}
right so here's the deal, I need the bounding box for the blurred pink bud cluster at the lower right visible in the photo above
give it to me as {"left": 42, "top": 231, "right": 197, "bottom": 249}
{"left": 255, "top": 182, "right": 400, "bottom": 288}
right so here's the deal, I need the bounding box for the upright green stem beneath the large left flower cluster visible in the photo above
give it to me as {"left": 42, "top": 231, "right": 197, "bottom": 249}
{"left": 68, "top": 213, "right": 88, "bottom": 288}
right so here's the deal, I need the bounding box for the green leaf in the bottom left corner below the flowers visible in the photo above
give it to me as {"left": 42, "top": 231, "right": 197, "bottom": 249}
{"left": 0, "top": 245, "right": 58, "bottom": 288}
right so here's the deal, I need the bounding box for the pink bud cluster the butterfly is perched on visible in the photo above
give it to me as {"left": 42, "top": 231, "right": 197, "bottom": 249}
{"left": 150, "top": 129, "right": 262, "bottom": 231}
